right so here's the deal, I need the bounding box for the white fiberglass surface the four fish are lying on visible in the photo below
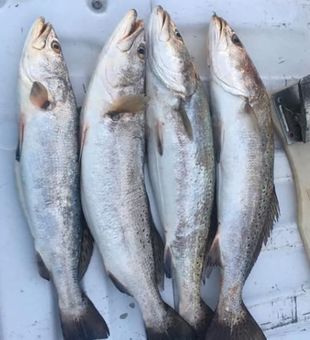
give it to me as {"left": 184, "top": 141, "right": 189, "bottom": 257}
{"left": 0, "top": 0, "right": 310, "bottom": 340}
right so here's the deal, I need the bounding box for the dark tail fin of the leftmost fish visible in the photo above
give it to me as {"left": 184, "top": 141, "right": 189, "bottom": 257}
{"left": 60, "top": 295, "right": 110, "bottom": 340}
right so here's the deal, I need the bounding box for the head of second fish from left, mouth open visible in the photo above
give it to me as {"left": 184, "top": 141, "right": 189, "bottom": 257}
{"left": 99, "top": 9, "right": 145, "bottom": 88}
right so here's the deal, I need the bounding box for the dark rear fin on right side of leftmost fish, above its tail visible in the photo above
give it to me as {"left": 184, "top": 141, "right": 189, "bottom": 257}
{"left": 79, "top": 217, "right": 94, "bottom": 280}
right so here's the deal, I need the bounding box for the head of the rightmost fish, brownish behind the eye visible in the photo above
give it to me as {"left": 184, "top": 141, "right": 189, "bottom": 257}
{"left": 209, "top": 14, "right": 262, "bottom": 97}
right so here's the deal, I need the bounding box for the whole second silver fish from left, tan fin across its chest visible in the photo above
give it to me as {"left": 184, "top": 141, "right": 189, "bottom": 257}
{"left": 81, "top": 10, "right": 192, "bottom": 340}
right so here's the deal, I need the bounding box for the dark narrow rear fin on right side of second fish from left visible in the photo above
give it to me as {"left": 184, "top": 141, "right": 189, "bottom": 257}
{"left": 151, "top": 222, "right": 165, "bottom": 291}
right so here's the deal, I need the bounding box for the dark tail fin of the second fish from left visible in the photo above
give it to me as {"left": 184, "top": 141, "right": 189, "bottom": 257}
{"left": 146, "top": 304, "right": 197, "bottom": 340}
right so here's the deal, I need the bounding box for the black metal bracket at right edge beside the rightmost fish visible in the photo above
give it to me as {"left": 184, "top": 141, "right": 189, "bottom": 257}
{"left": 272, "top": 75, "right": 310, "bottom": 144}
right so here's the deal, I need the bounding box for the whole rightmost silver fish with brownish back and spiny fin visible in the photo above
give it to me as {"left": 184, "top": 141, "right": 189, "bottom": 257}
{"left": 206, "top": 15, "right": 279, "bottom": 340}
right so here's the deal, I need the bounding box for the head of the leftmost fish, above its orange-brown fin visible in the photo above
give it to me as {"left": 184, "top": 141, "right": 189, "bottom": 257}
{"left": 20, "top": 17, "right": 67, "bottom": 83}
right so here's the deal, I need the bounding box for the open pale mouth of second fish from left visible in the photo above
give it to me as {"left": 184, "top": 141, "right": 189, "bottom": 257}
{"left": 116, "top": 9, "right": 144, "bottom": 52}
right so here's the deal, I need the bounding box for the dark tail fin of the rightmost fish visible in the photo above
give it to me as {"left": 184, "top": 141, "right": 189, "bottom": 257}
{"left": 205, "top": 303, "right": 266, "bottom": 340}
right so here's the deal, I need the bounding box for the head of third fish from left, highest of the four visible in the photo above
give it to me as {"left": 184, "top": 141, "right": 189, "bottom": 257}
{"left": 147, "top": 6, "right": 198, "bottom": 97}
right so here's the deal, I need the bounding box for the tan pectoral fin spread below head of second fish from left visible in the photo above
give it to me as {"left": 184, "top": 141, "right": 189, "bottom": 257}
{"left": 105, "top": 94, "right": 148, "bottom": 118}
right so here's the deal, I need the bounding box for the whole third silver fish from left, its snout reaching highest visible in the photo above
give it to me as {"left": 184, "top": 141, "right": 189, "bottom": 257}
{"left": 146, "top": 6, "right": 215, "bottom": 336}
